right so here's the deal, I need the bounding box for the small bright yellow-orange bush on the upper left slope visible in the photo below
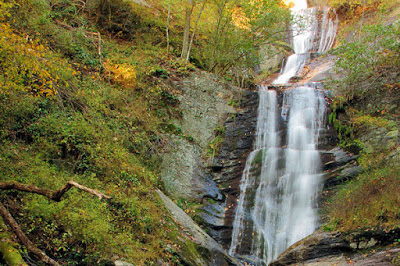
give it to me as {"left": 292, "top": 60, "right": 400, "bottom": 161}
{"left": 103, "top": 60, "right": 136, "bottom": 88}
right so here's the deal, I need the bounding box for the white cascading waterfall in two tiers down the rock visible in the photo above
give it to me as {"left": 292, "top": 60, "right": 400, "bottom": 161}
{"left": 229, "top": 1, "right": 337, "bottom": 265}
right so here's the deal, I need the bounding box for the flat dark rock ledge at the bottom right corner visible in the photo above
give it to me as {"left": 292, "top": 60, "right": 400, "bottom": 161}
{"left": 270, "top": 229, "right": 400, "bottom": 266}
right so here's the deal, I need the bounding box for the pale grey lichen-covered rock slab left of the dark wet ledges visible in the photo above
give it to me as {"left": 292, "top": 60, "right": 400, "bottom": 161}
{"left": 161, "top": 72, "right": 244, "bottom": 202}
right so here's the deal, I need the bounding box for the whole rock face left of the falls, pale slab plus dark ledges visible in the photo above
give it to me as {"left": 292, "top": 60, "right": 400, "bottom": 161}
{"left": 161, "top": 70, "right": 258, "bottom": 260}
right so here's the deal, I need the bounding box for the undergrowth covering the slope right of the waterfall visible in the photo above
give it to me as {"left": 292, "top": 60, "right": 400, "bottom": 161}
{"left": 323, "top": 7, "right": 400, "bottom": 231}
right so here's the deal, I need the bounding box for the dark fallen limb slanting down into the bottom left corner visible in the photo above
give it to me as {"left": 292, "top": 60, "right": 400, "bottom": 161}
{"left": 0, "top": 203, "right": 60, "bottom": 266}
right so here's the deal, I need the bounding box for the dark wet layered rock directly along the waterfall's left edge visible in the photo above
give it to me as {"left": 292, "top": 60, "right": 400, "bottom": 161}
{"left": 206, "top": 91, "right": 258, "bottom": 248}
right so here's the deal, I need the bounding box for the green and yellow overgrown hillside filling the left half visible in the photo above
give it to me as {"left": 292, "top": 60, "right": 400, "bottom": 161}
{"left": 0, "top": 0, "right": 200, "bottom": 265}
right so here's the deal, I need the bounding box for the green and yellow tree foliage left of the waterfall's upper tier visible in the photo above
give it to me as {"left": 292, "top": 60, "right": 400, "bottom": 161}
{"left": 202, "top": 1, "right": 290, "bottom": 74}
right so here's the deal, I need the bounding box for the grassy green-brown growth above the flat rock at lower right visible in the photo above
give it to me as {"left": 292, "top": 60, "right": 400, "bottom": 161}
{"left": 326, "top": 159, "right": 400, "bottom": 231}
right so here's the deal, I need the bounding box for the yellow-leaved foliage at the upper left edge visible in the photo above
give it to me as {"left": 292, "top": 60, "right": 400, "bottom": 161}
{"left": 0, "top": 1, "right": 77, "bottom": 97}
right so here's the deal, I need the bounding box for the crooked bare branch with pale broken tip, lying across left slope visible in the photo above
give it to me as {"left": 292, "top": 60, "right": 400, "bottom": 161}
{"left": 0, "top": 180, "right": 110, "bottom": 202}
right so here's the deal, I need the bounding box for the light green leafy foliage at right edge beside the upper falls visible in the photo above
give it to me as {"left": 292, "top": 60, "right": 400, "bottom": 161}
{"left": 334, "top": 23, "right": 400, "bottom": 99}
